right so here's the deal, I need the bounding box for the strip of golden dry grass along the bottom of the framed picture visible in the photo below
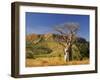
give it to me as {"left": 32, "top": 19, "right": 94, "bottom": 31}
{"left": 26, "top": 57, "right": 89, "bottom": 67}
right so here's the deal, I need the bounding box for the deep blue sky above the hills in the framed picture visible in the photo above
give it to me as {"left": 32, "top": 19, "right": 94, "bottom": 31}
{"left": 26, "top": 12, "right": 89, "bottom": 40}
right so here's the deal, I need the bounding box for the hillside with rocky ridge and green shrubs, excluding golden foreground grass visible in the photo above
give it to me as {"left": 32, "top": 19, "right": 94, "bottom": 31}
{"left": 26, "top": 33, "right": 89, "bottom": 59}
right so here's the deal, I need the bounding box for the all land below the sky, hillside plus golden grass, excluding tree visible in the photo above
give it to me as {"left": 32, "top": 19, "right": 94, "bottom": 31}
{"left": 26, "top": 34, "right": 89, "bottom": 67}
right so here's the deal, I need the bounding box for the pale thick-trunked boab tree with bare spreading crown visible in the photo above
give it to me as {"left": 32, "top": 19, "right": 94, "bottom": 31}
{"left": 54, "top": 23, "right": 80, "bottom": 61}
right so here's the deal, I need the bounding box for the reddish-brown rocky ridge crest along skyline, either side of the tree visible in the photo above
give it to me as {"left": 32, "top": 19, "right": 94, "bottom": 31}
{"left": 26, "top": 33, "right": 87, "bottom": 43}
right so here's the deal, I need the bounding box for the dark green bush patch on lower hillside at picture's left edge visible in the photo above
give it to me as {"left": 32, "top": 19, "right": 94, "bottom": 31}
{"left": 26, "top": 44, "right": 52, "bottom": 59}
